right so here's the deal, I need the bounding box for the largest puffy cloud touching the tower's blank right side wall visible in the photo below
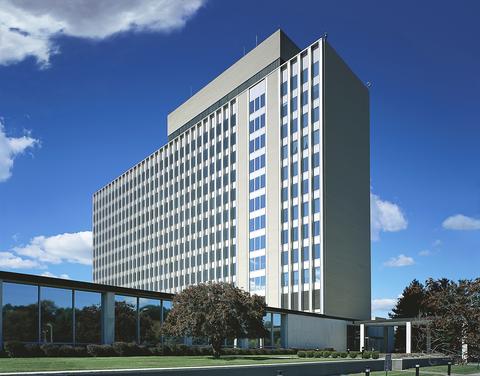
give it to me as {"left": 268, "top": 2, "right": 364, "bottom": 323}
{"left": 370, "top": 193, "right": 408, "bottom": 241}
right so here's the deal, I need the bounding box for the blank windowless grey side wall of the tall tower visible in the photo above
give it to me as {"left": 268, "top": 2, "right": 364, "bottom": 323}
{"left": 323, "top": 43, "right": 371, "bottom": 319}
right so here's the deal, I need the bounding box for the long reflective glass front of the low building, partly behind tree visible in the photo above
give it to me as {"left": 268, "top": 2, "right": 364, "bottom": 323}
{"left": 0, "top": 272, "right": 285, "bottom": 347}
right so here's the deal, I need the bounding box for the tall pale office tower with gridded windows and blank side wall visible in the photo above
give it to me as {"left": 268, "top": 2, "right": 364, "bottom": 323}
{"left": 93, "top": 31, "right": 370, "bottom": 319}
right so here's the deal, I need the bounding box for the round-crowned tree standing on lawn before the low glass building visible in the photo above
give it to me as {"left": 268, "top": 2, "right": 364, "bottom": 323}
{"left": 162, "top": 283, "right": 267, "bottom": 358}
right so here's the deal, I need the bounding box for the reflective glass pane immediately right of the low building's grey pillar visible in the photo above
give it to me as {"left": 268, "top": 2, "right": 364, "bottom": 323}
{"left": 115, "top": 295, "right": 137, "bottom": 342}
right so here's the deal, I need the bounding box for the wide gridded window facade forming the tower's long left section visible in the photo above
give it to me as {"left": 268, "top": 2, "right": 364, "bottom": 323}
{"left": 93, "top": 100, "right": 238, "bottom": 293}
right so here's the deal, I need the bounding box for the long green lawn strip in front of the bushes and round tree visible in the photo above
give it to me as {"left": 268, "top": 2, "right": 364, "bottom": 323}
{"left": 0, "top": 355, "right": 353, "bottom": 372}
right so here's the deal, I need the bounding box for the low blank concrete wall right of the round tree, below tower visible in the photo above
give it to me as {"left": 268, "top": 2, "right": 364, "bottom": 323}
{"left": 286, "top": 314, "right": 349, "bottom": 351}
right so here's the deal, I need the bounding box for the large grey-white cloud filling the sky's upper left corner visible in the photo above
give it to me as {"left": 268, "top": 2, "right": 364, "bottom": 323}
{"left": 0, "top": 0, "right": 205, "bottom": 67}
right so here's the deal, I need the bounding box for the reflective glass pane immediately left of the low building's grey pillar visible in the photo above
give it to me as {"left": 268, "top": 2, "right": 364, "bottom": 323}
{"left": 75, "top": 291, "right": 102, "bottom": 343}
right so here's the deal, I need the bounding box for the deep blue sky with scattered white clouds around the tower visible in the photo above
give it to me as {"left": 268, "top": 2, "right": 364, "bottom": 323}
{"left": 0, "top": 0, "right": 480, "bottom": 317}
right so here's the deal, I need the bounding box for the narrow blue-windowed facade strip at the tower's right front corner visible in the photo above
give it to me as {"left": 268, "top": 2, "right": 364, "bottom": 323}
{"left": 279, "top": 44, "right": 322, "bottom": 312}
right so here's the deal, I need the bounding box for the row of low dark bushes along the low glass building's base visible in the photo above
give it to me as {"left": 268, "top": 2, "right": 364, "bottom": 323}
{"left": 0, "top": 341, "right": 297, "bottom": 358}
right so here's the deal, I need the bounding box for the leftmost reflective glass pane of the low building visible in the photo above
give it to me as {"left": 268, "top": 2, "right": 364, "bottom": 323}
{"left": 3, "top": 282, "right": 38, "bottom": 342}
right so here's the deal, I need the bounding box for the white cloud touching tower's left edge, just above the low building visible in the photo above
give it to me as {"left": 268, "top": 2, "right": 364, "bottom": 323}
{"left": 13, "top": 231, "right": 92, "bottom": 265}
